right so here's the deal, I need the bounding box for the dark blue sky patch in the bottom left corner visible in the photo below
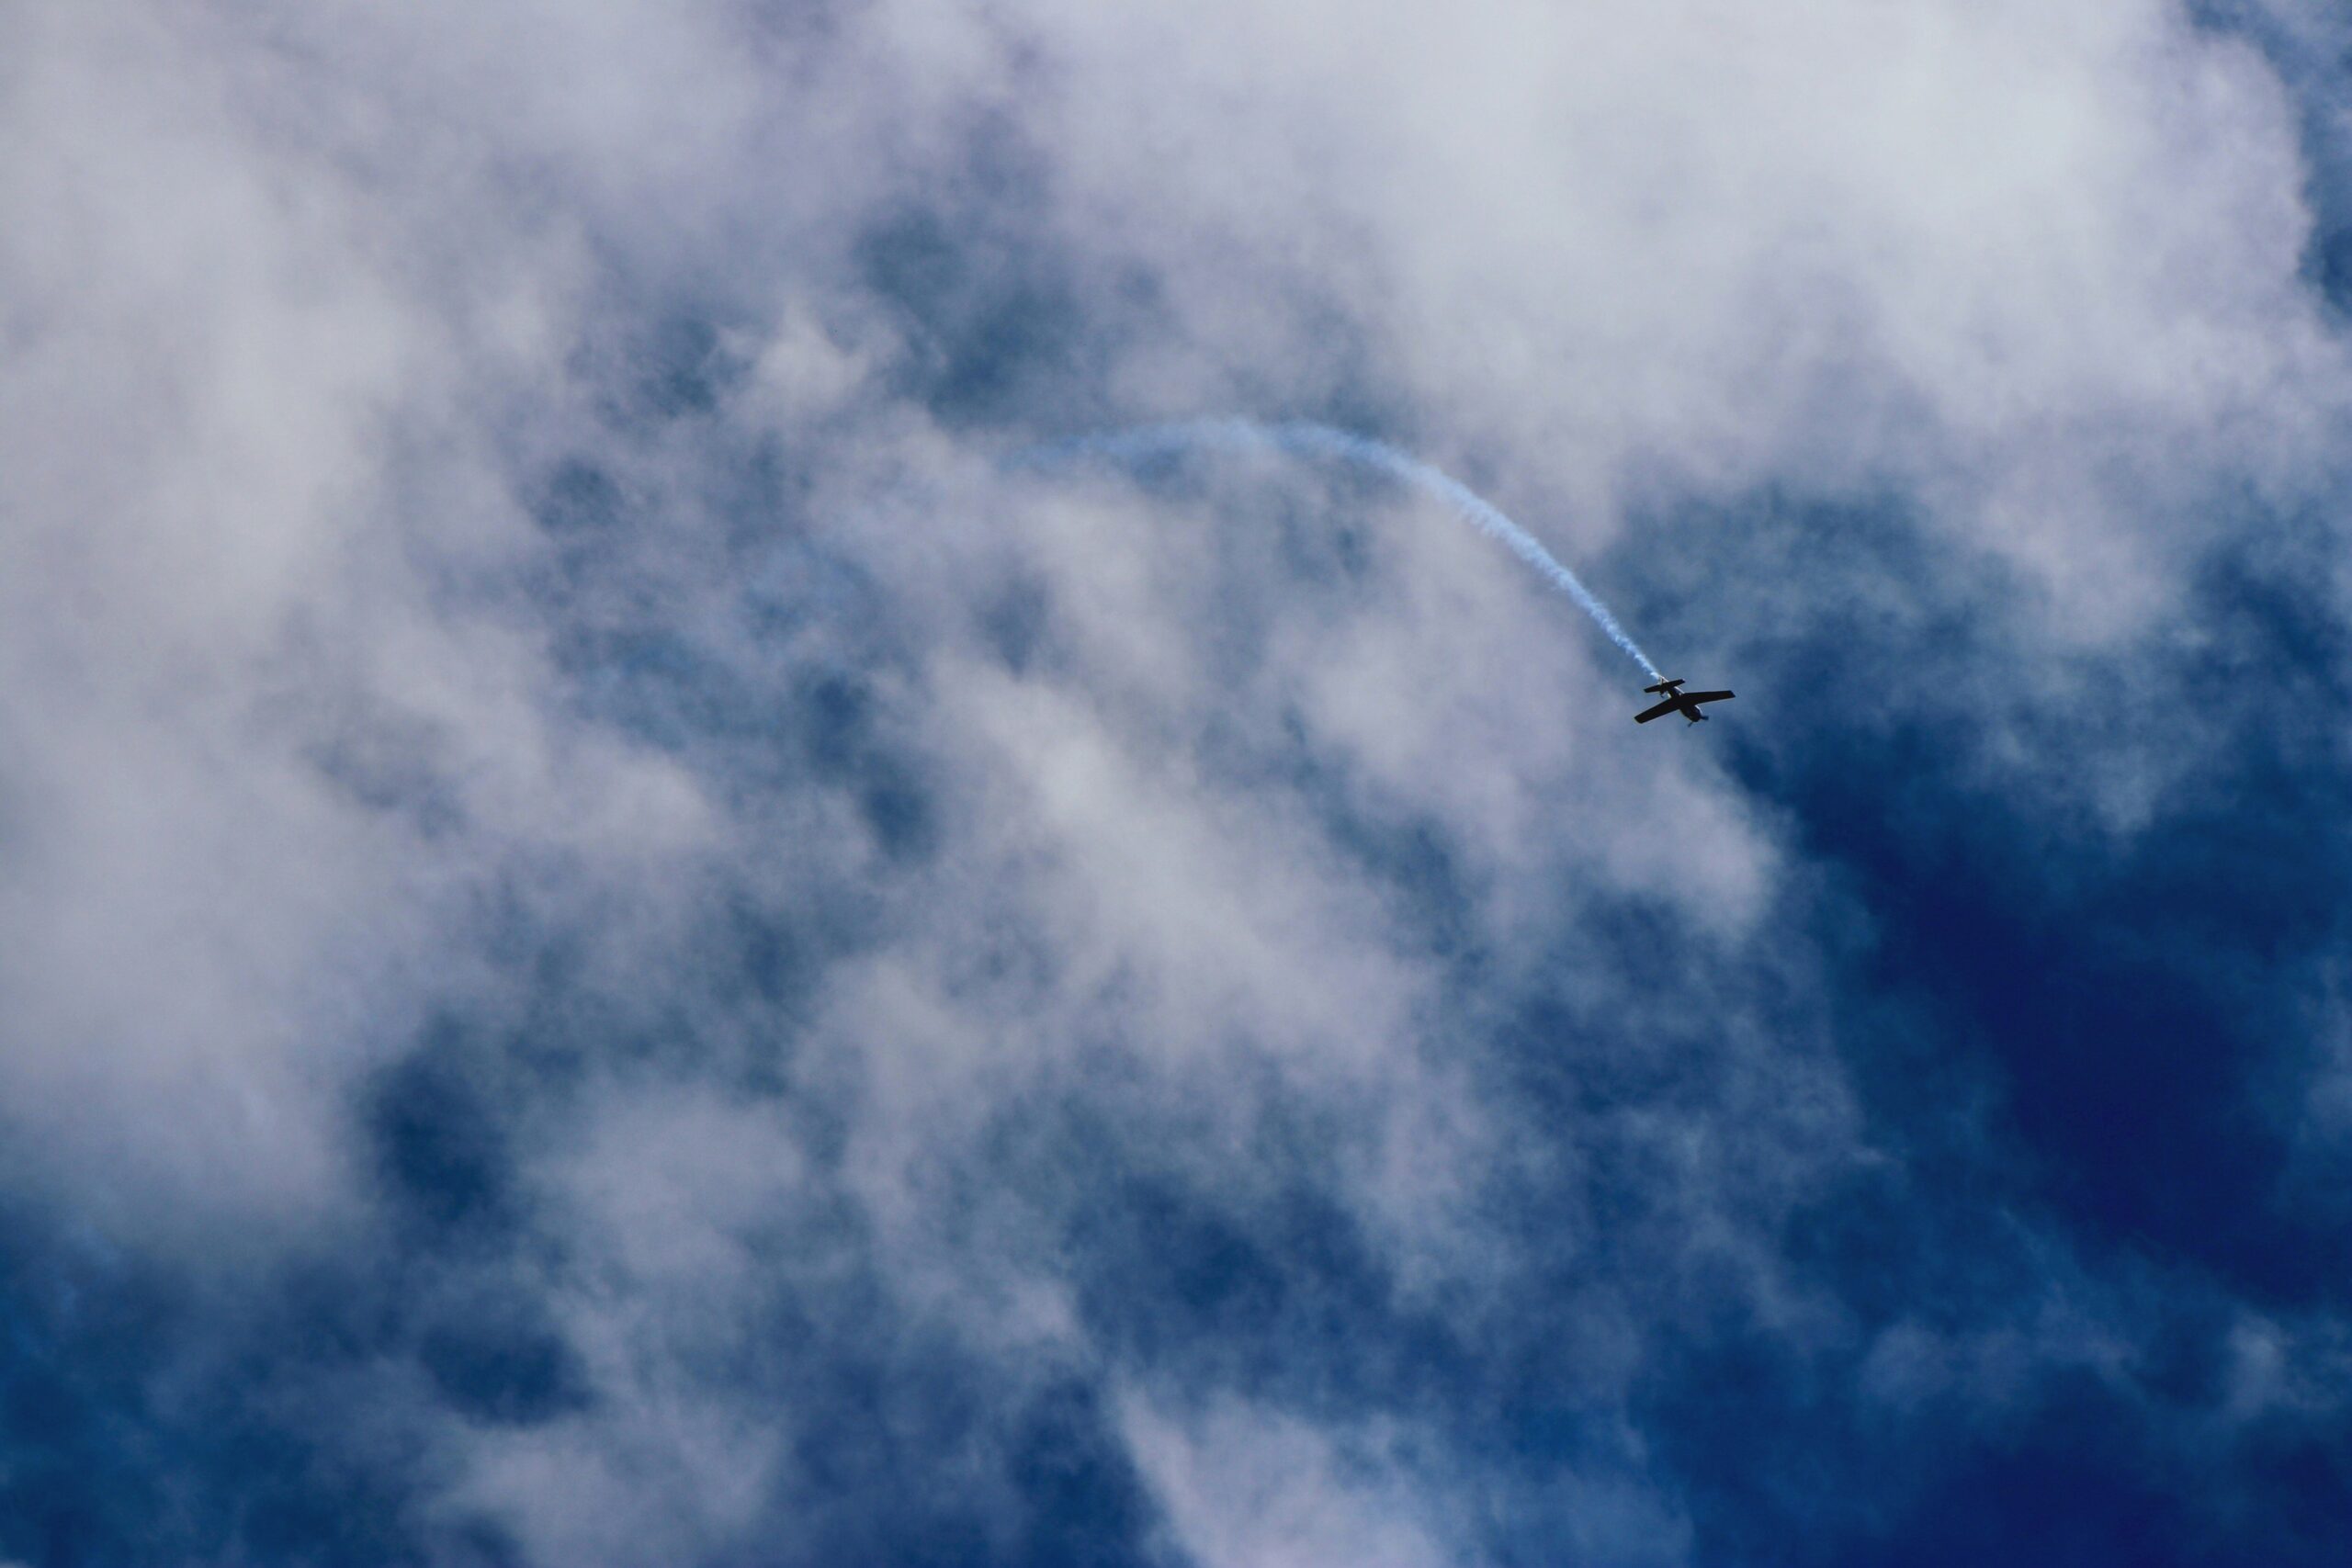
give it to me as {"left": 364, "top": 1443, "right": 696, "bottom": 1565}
{"left": 0, "top": 1211, "right": 499, "bottom": 1568}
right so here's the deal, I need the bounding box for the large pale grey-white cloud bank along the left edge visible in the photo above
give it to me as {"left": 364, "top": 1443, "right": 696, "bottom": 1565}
{"left": 0, "top": 5, "right": 724, "bottom": 1248}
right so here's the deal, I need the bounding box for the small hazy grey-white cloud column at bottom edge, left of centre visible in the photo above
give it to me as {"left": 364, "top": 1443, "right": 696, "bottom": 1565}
{"left": 447, "top": 1081, "right": 826, "bottom": 1563}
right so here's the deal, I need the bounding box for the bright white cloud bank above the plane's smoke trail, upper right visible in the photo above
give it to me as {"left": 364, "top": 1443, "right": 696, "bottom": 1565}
{"left": 968, "top": 0, "right": 2343, "bottom": 632}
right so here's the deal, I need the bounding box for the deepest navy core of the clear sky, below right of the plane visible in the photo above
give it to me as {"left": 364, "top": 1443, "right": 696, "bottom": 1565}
{"left": 1782, "top": 629, "right": 2352, "bottom": 1300}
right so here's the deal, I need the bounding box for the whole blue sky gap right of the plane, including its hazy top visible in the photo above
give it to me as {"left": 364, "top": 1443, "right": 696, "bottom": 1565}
{"left": 1651, "top": 479, "right": 2352, "bottom": 1304}
